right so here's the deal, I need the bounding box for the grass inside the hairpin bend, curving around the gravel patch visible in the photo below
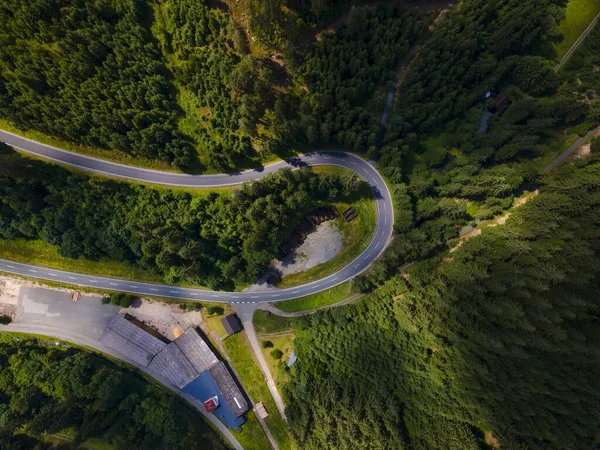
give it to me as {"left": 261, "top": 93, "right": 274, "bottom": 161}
{"left": 278, "top": 167, "right": 377, "bottom": 288}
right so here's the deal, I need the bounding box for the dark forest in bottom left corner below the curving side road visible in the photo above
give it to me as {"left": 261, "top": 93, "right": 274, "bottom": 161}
{"left": 0, "top": 334, "right": 228, "bottom": 450}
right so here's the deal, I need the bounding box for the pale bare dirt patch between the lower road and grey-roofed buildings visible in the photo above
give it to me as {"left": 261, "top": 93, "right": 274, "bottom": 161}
{"left": 121, "top": 300, "right": 204, "bottom": 340}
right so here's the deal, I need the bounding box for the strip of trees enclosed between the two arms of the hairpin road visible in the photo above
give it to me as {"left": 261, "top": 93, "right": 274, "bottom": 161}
{"left": 0, "top": 144, "right": 362, "bottom": 290}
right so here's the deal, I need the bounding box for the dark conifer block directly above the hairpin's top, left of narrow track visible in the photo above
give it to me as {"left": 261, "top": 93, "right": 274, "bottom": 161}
{"left": 297, "top": 7, "right": 425, "bottom": 153}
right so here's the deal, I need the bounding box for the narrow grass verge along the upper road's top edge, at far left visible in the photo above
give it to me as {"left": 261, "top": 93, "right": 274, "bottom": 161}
{"left": 0, "top": 119, "right": 179, "bottom": 172}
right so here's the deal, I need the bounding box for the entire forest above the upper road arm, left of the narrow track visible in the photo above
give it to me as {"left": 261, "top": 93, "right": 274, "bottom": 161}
{"left": 0, "top": 0, "right": 429, "bottom": 172}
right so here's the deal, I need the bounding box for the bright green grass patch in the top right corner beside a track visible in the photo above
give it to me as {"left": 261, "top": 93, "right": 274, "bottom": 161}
{"left": 553, "top": 0, "right": 600, "bottom": 59}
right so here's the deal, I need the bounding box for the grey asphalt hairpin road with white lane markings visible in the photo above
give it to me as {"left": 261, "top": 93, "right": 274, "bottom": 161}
{"left": 0, "top": 130, "right": 394, "bottom": 303}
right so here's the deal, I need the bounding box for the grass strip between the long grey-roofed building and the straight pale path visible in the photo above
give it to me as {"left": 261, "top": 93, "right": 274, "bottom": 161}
{"left": 223, "top": 332, "right": 294, "bottom": 450}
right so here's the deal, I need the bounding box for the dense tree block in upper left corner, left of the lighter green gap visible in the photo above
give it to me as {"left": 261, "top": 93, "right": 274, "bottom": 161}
{"left": 0, "top": 0, "right": 192, "bottom": 167}
